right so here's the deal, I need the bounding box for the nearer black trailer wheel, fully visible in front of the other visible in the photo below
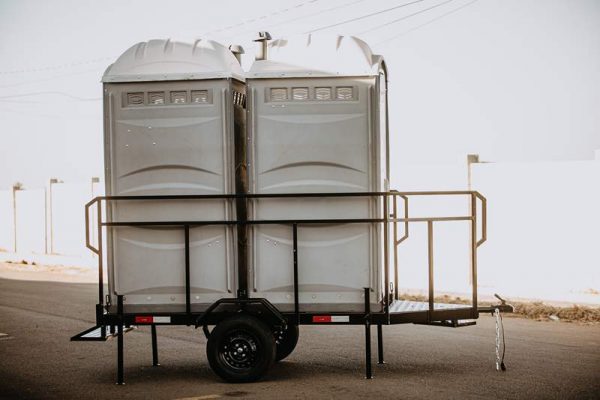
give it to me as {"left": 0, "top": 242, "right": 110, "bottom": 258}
{"left": 206, "top": 314, "right": 275, "bottom": 382}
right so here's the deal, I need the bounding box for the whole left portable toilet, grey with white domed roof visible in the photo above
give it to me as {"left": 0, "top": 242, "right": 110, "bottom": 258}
{"left": 102, "top": 40, "right": 245, "bottom": 311}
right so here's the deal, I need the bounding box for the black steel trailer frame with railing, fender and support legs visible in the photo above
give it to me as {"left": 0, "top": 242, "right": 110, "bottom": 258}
{"left": 72, "top": 191, "right": 487, "bottom": 384}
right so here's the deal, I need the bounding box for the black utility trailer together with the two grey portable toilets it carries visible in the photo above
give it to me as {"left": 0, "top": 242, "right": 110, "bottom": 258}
{"left": 71, "top": 33, "right": 512, "bottom": 384}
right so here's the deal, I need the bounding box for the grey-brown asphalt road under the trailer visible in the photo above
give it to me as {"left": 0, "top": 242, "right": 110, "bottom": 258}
{"left": 0, "top": 279, "right": 600, "bottom": 399}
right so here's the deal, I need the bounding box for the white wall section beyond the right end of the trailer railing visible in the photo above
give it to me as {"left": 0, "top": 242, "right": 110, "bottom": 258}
{"left": 473, "top": 161, "right": 600, "bottom": 303}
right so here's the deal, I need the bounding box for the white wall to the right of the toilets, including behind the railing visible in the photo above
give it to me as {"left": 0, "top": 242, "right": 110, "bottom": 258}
{"left": 392, "top": 161, "right": 600, "bottom": 304}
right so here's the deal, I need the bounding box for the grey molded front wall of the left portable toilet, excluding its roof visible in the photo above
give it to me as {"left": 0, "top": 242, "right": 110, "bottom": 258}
{"left": 105, "top": 80, "right": 235, "bottom": 304}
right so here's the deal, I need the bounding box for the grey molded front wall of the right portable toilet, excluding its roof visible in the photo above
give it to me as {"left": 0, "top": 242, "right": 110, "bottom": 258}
{"left": 247, "top": 78, "right": 385, "bottom": 310}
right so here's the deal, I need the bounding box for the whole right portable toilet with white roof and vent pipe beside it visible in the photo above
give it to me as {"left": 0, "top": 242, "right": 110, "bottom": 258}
{"left": 246, "top": 35, "right": 388, "bottom": 311}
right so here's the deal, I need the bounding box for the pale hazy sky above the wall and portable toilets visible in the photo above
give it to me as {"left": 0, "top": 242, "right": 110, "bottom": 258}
{"left": 0, "top": 0, "right": 600, "bottom": 189}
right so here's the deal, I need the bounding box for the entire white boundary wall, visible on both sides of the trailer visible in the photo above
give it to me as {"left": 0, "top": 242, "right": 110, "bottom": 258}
{"left": 0, "top": 161, "right": 600, "bottom": 304}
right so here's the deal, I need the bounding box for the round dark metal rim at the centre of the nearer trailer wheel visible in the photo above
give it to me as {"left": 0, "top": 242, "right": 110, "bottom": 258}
{"left": 219, "top": 331, "right": 259, "bottom": 370}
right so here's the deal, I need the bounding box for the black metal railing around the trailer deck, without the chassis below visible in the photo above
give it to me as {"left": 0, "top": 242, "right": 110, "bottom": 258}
{"left": 85, "top": 191, "right": 487, "bottom": 321}
